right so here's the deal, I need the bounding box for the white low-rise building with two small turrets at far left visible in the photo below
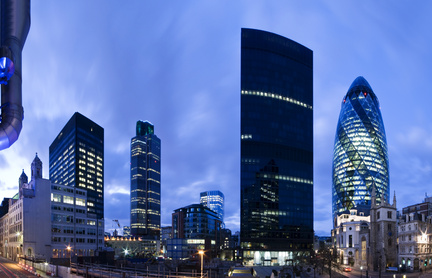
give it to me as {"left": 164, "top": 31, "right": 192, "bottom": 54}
{"left": 0, "top": 155, "right": 104, "bottom": 261}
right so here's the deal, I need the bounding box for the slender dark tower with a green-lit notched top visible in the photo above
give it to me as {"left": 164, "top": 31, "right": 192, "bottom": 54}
{"left": 131, "top": 121, "right": 161, "bottom": 239}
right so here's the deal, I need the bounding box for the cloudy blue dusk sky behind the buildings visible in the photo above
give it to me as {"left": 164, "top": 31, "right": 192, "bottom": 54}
{"left": 0, "top": 0, "right": 432, "bottom": 235}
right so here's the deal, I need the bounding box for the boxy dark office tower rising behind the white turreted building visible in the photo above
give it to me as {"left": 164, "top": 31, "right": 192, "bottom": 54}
{"left": 49, "top": 112, "right": 104, "bottom": 219}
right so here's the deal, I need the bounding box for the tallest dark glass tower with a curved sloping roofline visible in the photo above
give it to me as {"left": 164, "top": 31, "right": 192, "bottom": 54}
{"left": 240, "top": 29, "right": 313, "bottom": 265}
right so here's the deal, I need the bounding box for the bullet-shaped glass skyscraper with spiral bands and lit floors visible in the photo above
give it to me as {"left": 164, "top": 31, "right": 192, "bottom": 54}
{"left": 332, "top": 76, "right": 390, "bottom": 222}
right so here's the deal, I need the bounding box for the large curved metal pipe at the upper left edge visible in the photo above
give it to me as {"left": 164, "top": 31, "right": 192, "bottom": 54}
{"left": 0, "top": 0, "right": 30, "bottom": 150}
